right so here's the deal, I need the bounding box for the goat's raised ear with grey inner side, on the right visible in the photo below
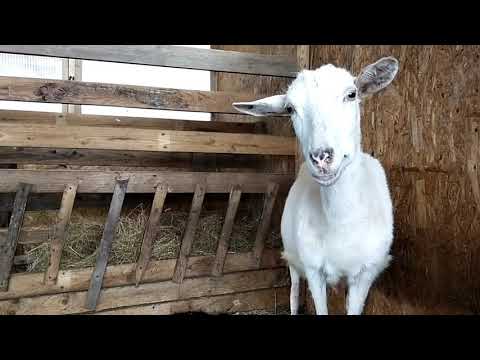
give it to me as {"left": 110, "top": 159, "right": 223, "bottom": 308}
{"left": 355, "top": 56, "right": 398, "bottom": 97}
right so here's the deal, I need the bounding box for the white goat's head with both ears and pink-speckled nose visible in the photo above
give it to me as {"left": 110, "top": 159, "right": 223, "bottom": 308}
{"left": 233, "top": 57, "right": 398, "bottom": 186}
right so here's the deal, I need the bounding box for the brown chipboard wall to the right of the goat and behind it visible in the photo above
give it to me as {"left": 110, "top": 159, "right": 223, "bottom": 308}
{"left": 311, "top": 46, "right": 480, "bottom": 314}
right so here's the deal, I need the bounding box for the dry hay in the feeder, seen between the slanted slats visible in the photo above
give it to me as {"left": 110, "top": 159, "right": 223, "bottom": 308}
{"left": 20, "top": 206, "right": 281, "bottom": 272}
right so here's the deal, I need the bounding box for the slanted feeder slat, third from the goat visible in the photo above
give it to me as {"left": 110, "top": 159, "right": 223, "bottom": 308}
{"left": 172, "top": 183, "right": 206, "bottom": 283}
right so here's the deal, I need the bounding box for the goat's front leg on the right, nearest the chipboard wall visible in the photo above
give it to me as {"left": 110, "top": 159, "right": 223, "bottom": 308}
{"left": 347, "top": 268, "right": 378, "bottom": 315}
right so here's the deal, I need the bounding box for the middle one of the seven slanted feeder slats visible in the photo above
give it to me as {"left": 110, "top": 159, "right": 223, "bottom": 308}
{"left": 135, "top": 184, "right": 168, "bottom": 286}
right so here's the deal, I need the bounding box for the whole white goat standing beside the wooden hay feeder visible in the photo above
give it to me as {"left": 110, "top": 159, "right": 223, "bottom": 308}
{"left": 233, "top": 57, "right": 398, "bottom": 315}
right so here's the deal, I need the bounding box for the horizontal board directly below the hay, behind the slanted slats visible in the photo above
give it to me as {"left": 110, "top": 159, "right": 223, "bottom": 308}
{"left": 0, "top": 249, "right": 284, "bottom": 300}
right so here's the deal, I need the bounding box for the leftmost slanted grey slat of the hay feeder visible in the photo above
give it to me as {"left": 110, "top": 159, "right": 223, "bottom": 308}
{"left": 0, "top": 182, "right": 32, "bottom": 291}
